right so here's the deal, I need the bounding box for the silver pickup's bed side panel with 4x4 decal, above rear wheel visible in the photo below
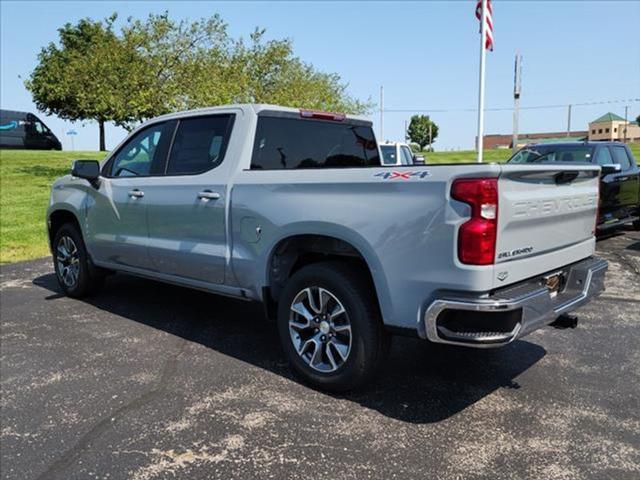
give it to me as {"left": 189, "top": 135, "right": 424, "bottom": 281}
{"left": 230, "top": 165, "right": 500, "bottom": 328}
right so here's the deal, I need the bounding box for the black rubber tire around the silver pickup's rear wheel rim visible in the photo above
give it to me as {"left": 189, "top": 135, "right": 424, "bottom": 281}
{"left": 277, "top": 262, "right": 389, "bottom": 392}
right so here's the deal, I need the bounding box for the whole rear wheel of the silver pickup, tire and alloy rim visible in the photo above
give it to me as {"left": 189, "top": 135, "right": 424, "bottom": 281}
{"left": 278, "top": 262, "right": 389, "bottom": 391}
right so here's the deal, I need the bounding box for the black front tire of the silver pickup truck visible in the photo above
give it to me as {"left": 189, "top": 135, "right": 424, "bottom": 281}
{"left": 53, "top": 223, "right": 105, "bottom": 298}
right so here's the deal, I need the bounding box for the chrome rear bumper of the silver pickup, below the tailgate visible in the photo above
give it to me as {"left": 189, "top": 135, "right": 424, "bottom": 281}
{"left": 421, "top": 257, "right": 608, "bottom": 348}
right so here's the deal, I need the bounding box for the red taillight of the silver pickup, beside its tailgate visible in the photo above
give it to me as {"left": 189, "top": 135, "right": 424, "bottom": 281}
{"left": 451, "top": 178, "right": 498, "bottom": 265}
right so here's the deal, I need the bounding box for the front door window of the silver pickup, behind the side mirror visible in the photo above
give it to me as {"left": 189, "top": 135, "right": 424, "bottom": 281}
{"left": 109, "top": 123, "right": 165, "bottom": 177}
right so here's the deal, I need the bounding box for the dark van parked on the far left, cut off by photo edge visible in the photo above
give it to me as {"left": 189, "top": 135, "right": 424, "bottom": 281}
{"left": 0, "top": 110, "right": 62, "bottom": 150}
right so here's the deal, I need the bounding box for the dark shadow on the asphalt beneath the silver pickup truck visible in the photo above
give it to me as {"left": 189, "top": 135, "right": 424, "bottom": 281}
{"left": 33, "top": 273, "right": 546, "bottom": 423}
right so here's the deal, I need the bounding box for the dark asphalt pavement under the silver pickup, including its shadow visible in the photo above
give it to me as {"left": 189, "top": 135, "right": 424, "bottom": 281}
{"left": 0, "top": 231, "right": 640, "bottom": 480}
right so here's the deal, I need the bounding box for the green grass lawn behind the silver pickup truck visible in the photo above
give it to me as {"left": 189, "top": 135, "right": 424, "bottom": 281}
{"left": 0, "top": 144, "right": 640, "bottom": 263}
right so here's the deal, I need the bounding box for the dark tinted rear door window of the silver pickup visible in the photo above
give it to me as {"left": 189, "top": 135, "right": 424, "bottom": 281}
{"left": 166, "top": 115, "right": 234, "bottom": 175}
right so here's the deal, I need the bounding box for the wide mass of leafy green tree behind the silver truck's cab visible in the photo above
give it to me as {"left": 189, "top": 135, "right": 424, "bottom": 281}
{"left": 25, "top": 13, "right": 371, "bottom": 150}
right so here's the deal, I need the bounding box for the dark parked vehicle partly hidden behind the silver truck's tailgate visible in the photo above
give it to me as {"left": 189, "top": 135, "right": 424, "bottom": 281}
{"left": 508, "top": 142, "right": 640, "bottom": 232}
